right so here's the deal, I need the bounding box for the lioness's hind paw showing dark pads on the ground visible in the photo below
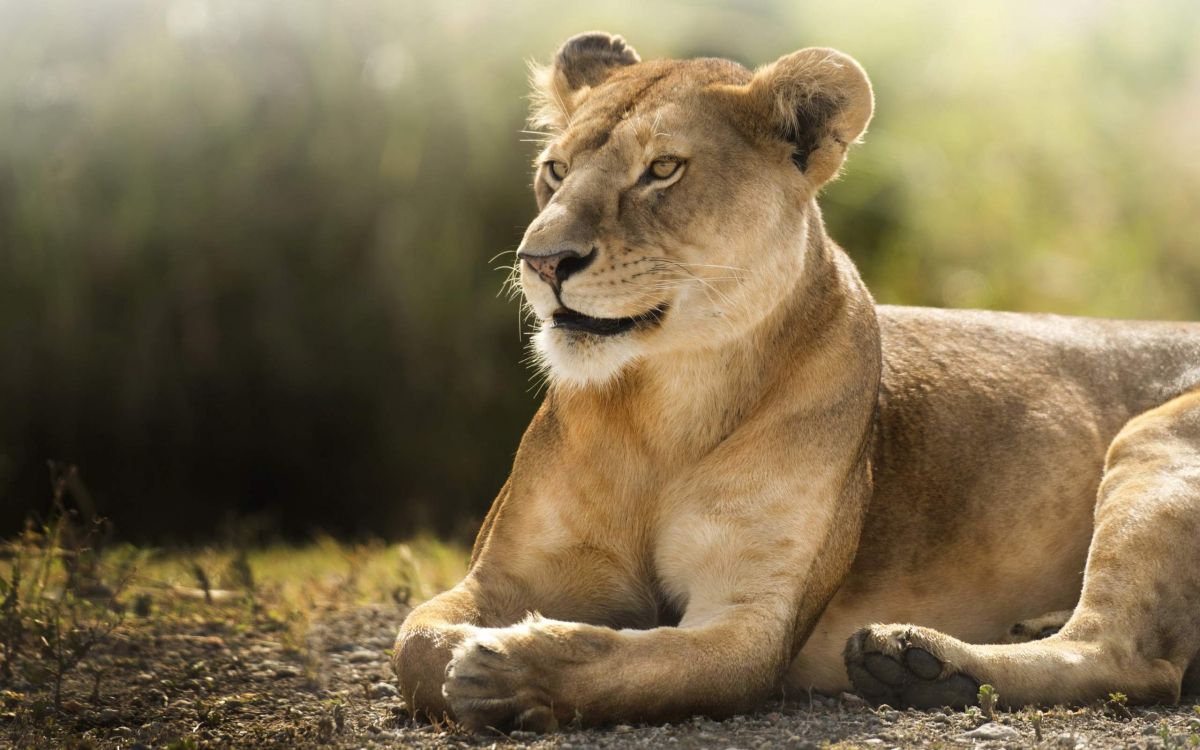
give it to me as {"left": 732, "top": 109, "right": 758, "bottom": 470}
{"left": 844, "top": 625, "right": 980, "bottom": 708}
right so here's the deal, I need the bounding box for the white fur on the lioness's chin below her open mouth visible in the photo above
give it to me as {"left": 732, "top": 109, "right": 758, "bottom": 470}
{"left": 533, "top": 322, "right": 638, "bottom": 388}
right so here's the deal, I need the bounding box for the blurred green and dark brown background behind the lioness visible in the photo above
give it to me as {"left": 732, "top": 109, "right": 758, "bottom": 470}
{"left": 0, "top": 0, "right": 1200, "bottom": 542}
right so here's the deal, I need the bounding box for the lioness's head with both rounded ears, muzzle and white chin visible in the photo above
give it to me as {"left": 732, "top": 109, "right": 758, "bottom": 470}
{"left": 518, "top": 32, "right": 872, "bottom": 385}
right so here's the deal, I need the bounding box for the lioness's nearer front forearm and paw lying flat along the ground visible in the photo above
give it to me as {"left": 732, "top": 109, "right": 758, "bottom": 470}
{"left": 444, "top": 602, "right": 791, "bottom": 731}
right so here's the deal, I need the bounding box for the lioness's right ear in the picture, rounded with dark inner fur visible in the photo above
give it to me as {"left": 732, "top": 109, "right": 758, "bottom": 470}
{"left": 750, "top": 47, "right": 875, "bottom": 187}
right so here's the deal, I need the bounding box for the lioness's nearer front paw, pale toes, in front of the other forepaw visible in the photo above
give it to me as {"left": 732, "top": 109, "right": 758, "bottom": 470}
{"left": 442, "top": 632, "right": 558, "bottom": 732}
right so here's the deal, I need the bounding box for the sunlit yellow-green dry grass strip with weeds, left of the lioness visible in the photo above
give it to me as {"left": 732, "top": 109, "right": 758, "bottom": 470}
{"left": 0, "top": 506, "right": 467, "bottom": 712}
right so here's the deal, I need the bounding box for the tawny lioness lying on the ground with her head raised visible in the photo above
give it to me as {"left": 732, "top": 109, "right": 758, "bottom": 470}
{"left": 394, "top": 34, "right": 1200, "bottom": 730}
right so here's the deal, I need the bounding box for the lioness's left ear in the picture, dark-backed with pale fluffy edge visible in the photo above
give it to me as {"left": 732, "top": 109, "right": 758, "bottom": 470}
{"left": 529, "top": 31, "right": 642, "bottom": 128}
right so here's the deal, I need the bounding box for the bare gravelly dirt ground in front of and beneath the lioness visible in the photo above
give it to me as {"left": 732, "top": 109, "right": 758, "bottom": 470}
{"left": 0, "top": 605, "right": 1200, "bottom": 750}
